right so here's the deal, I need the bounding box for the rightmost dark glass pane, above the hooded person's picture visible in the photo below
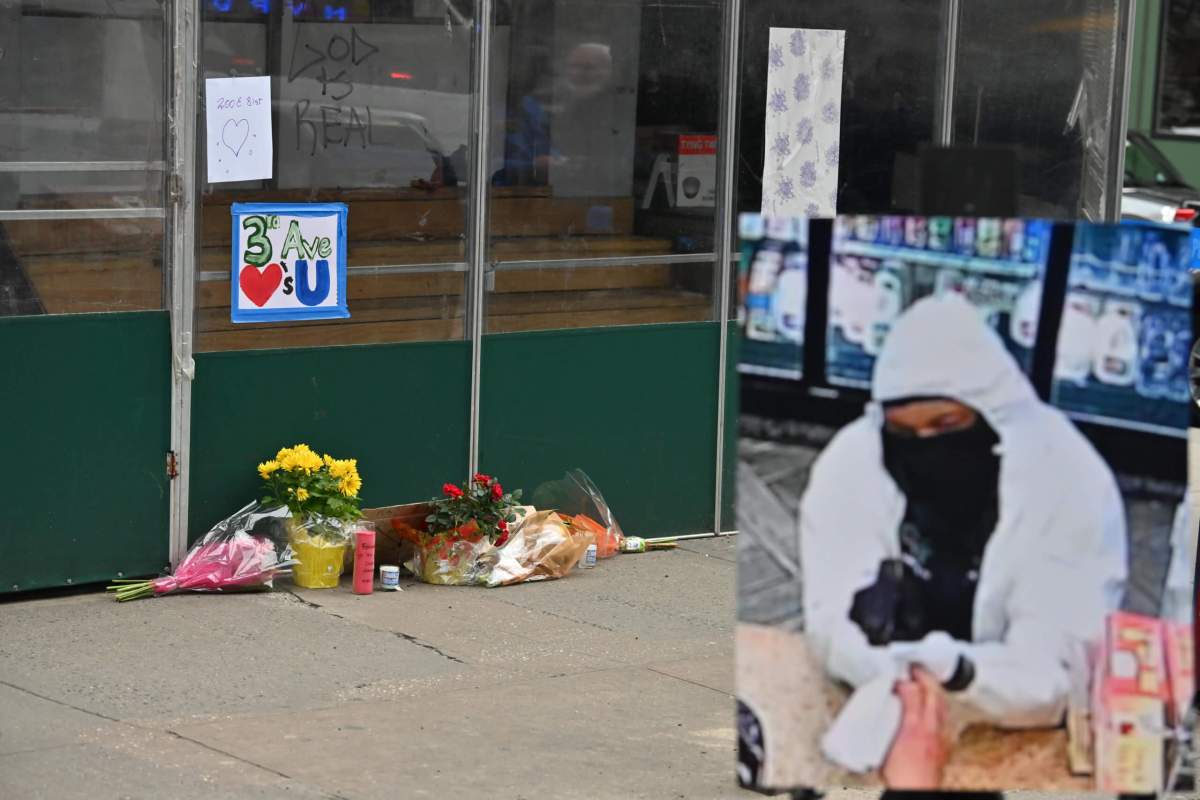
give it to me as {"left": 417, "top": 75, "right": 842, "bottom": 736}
{"left": 954, "top": 0, "right": 1123, "bottom": 219}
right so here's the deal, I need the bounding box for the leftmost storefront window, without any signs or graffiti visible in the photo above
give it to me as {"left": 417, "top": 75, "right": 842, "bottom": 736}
{"left": 0, "top": 0, "right": 167, "bottom": 315}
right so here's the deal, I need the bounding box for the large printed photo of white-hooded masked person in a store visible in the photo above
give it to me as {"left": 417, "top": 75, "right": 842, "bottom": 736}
{"left": 737, "top": 216, "right": 1200, "bottom": 794}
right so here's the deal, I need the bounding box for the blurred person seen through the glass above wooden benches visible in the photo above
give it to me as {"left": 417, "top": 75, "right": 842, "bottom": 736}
{"left": 492, "top": 42, "right": 613, "bottom": 186}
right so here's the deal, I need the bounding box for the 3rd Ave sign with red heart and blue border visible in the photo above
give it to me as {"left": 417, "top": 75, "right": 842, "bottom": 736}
{"left": 229, "top": 203, "right": 350, "bottom": 323}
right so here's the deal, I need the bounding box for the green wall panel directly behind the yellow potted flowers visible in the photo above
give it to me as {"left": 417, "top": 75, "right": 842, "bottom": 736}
{"left": 188, "top": 342, "right": 470, "bottom": 540}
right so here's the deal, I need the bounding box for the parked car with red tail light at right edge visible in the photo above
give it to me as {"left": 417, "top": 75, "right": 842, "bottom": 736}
{"left": 1121, "top": 131, "right": 1200, "bottom": 224}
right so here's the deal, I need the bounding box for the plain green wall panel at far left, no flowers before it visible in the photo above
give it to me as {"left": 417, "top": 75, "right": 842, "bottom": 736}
{"left": 0, "top": 312, "right": 170, "bottom": 593}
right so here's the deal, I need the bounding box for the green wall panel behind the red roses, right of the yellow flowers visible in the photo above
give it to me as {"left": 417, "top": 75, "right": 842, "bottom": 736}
{"left": 480, "top": 323, "right": 720, "bottom": 536}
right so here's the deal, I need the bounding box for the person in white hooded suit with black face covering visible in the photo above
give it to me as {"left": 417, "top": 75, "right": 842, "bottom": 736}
{"left": 799, "top": 295, "right": 1127, "bottom": 790}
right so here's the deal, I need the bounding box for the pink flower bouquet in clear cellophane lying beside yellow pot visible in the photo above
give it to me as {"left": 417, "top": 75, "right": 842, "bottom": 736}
{"left": 109, "top": 503, "right": 296, "bottom": 601}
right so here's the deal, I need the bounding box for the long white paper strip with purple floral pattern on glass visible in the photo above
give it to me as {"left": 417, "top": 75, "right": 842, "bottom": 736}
{"left": 762, "top": 28, "right": 846, "bottom": 217}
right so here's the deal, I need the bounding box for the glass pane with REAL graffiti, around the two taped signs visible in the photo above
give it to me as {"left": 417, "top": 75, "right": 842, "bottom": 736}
{"left": 197, "top": 0, "right": 472, "bottom": 350}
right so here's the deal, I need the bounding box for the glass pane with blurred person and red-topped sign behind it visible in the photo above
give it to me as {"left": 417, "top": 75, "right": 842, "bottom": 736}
{"left": 486, "top": 0, "right": 721, "bottom": 332}
